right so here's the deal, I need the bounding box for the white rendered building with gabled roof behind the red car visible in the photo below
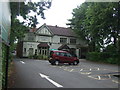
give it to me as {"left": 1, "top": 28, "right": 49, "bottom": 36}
{"left": 17, "top": 24, "right": 86, "bottom": 58}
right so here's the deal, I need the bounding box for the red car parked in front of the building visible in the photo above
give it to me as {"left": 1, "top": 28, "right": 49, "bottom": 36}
{"left": 49, "top": 50, "right": 79, "bottom": 65}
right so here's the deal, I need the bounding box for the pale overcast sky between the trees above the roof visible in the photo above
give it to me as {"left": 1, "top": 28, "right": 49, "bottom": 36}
{"left": 17, "top": 0, "right": 85, "bottom": 27}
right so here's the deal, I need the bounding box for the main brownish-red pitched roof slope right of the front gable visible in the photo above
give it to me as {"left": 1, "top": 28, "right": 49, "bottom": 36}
{"left": 46, "top": 25, "right": 76, "bottom": 37}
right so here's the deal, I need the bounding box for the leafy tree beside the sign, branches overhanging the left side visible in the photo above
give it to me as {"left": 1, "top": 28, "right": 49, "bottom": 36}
{"left": 10, "top": 0, "right": 51, "bottom": 51}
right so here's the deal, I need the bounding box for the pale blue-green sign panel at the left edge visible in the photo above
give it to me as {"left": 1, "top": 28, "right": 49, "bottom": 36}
{"left": 0, "top": 2, "right": 11, "bottom": 44}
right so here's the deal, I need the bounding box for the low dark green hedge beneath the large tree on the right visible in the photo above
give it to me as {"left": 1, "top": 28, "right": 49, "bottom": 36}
{"left": 87, "top": 52, "right": 120, "bottom": 65}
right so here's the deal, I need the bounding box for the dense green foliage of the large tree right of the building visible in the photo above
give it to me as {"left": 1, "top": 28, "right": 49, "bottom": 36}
{"left": 68, "top": 2, "right": 120, "bottom": 52}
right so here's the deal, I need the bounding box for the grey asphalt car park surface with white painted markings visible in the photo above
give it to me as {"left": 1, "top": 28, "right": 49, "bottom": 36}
{"left": 13, "top": 59, "right": 120, "bottom": 88}
